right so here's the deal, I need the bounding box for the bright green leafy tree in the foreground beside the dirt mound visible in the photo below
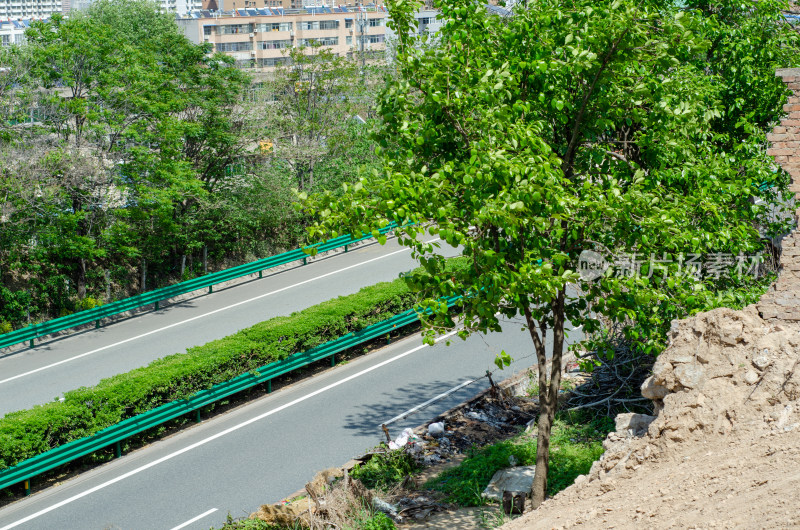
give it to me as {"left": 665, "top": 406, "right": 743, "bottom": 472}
{"left": 300, "top": 0, "right": 786, "bottom": 506}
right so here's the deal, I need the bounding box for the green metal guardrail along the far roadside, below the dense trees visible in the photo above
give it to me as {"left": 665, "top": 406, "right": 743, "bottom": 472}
{"left": 0, "top": 223, "right": 397, "bottom": 348}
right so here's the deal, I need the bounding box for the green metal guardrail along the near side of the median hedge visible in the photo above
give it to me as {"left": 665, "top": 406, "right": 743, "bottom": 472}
{"left": 0, "top": 296, "right": 461, "bottom": 494}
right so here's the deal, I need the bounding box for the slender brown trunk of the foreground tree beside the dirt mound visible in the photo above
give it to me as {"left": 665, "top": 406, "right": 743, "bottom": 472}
{"left": 531, "top": 290, "right": 566, "bottom": 509}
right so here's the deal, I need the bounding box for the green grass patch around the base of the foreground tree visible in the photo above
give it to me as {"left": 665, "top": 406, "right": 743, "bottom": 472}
{"left": 425, "top": 412, "right": 614, "bottom": 506}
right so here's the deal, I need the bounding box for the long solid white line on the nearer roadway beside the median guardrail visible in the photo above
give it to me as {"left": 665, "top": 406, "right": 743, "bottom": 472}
{"left": 0, "top": 330, "right": 458, "bottom": 530}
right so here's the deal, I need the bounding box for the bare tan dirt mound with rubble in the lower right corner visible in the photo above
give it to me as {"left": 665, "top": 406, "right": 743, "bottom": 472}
{"left": 503, "top": 306, "right": 800, "bottom": 530}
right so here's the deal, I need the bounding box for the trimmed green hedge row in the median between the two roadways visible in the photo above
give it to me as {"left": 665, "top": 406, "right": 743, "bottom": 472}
{"left": 0, "top": 279, "right": 422, "bottom": 470}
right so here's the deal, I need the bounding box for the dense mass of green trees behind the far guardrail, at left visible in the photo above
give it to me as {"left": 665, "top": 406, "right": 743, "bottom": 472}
{"left": 0, "top": 0, "right": 374, "bottom": 331}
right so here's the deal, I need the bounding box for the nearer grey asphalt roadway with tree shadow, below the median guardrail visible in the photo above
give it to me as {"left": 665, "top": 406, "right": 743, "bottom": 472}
{"left": 0, "top": 316, "right": 582, "bottom": 530}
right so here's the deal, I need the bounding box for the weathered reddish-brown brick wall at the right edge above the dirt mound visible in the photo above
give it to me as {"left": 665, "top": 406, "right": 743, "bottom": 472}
{"left": 758, "top": 68, "right": 800, "bottom": 321}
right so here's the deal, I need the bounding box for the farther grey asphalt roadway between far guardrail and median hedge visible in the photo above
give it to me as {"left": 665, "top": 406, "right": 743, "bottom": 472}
{"left": 0, "top": 236, "right": 458, "bottom": 417}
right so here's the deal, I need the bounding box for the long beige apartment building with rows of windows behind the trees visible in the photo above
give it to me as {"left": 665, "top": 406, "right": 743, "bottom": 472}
{"left": 177, "top": 6, "right": 388, "bottom": 69}
